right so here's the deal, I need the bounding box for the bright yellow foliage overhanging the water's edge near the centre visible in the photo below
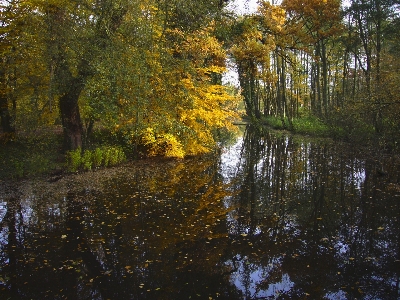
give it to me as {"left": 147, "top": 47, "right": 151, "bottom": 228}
{"left": 88, "top": 14, "right": 240, "bottom": 158}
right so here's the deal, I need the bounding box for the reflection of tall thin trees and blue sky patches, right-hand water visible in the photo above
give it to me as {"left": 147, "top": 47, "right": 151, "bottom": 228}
{"left": 227, "top": 128, "right": 399, "bottom": 299}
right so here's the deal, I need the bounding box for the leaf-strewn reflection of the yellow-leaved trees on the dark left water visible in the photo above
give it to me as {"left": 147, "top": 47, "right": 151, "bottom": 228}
{"left": 0, "top": 157, "right": 242, "bottom": 299}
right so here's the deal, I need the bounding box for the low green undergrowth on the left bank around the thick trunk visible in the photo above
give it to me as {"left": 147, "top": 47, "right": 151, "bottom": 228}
{"left": 0, "top": 128, "right": 126, "bottom": 181}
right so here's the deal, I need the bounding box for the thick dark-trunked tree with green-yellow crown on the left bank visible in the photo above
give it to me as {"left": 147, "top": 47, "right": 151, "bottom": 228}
{"left": 39, "top": 0, "right": 127, "bottom": 149}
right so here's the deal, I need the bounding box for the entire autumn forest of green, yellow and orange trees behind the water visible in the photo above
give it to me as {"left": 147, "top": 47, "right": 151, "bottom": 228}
{"left": 0, "top": 0, "right": 400, "bottom": 175}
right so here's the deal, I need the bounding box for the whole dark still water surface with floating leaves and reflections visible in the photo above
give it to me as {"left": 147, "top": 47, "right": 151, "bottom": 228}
{"left": 0, "top": 128, "right": 400, "bottom": 299}
